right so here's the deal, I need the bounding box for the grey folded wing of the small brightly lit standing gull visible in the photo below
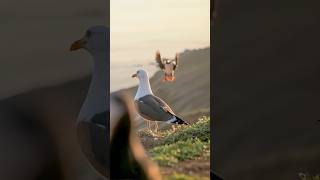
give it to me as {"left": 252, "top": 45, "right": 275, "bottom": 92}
{"left": 135, "top": 95, "right": 174, "bottom": 121}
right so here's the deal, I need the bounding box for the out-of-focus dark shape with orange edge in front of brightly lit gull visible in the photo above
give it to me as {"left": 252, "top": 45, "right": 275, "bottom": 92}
{"left": 110, "top": 93, "right": 161, "bottom": 180}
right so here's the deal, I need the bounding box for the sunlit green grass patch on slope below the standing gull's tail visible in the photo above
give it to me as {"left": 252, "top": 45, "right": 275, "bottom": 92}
{"left": 149, "top": 117, "right": 210, "bottom": 166}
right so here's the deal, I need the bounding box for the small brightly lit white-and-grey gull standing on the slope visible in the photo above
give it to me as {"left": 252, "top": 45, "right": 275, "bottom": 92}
{"left": 132, "top": 69, "right": 188, "bottom": 131}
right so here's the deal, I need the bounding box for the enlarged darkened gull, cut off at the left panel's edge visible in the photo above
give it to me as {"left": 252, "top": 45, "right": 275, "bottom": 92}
{"left": 70, "top": 25, "right": 110, "bottom": 177}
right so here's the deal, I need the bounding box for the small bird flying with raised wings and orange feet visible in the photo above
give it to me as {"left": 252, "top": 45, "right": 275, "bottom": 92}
{"left": 155, "top": 51, "right": 178, "bottom": 82}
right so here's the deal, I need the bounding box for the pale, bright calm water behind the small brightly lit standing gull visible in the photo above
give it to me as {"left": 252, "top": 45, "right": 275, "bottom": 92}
{"left": 110, "top": 0, "right": 210, "bottom": 91}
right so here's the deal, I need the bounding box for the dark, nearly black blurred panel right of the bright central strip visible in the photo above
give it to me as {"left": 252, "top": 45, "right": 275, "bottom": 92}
{"left": 211, "top": 0, "right": 320, "bottom": 180}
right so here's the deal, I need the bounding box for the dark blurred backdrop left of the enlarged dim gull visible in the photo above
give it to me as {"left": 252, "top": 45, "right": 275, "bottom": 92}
{"left": 0, "top": 0, "right": 109, "bottom": 180}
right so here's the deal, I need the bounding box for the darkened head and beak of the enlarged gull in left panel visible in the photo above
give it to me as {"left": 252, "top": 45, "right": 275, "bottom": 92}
{"left": 70, "top": 25, "right": 109, "bottom": 54}
